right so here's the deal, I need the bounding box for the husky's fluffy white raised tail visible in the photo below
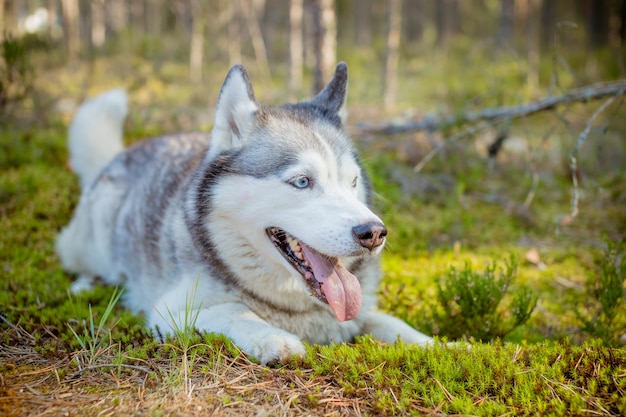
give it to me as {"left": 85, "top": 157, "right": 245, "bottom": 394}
{"left": 68, "top": 89, "right": 128, "bottom": 189}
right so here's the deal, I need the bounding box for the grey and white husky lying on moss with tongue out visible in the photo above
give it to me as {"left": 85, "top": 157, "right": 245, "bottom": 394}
{"left": 57, "top": 63, "right": 432, "bottom": 364}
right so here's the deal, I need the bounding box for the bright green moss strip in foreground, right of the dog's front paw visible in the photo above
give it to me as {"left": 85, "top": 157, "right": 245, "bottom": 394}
{"left": 294, "top": 338, "right": 626, "bottom": 415}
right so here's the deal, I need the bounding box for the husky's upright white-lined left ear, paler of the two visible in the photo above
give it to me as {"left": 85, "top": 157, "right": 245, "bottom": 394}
{"left": 207, "top": 65, "right": 259, "bottom": 160}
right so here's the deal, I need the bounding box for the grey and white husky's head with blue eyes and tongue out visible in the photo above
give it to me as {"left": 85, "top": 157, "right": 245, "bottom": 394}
{"left": 197, "top": 63, "right": 387, "bottom": 321}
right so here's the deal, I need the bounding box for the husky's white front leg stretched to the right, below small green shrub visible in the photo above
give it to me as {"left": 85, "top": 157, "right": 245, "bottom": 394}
{"left": 363, "top": 312, "right": 433, "bottom": 345}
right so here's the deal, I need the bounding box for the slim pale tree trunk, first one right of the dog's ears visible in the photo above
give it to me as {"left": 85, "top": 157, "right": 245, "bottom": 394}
{"left": 383, "top": 0, "right": 402, "bottom": 107}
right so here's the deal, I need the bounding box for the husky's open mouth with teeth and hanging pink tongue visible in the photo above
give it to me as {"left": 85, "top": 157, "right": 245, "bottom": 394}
{"left": 266, "top": 227, "right": 363, "bottom": 321}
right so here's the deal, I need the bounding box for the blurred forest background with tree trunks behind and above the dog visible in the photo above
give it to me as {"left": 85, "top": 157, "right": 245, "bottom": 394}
{"left": 0, "top": 0, "right": 626, "bottom": 182}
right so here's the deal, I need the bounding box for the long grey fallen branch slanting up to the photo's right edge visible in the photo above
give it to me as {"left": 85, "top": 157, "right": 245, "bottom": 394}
{"left": 358, "top": 80, "right": 626, "bottom": 134}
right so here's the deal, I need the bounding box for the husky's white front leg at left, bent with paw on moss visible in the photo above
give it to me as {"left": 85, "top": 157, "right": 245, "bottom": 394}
{"left": 150, "top": 303, "right": 305, "bottom": 364}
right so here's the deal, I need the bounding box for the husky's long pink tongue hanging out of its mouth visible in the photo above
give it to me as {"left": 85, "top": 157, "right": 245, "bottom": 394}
{"left": 302, "top": 245, "right": 363, "bottom": 321}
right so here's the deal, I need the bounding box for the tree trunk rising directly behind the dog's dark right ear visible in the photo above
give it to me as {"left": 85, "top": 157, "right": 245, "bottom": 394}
{"left": 312, "top": 0, "right": 337, "bottom": 94}
